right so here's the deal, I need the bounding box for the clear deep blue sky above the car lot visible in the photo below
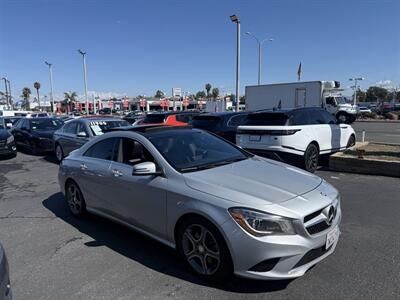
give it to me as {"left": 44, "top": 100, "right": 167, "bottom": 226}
{"left": 0, "top": 0, "right": 400, "bottom": 101}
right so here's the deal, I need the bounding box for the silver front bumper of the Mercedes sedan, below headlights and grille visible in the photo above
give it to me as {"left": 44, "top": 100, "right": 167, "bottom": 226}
{"left": 223, "top": 206, "right": 341, "bottom": 280}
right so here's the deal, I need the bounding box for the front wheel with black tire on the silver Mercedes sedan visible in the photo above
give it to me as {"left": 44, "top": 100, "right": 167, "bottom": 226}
{"left": 177, "top": 216, "right": 232, "bottom": 281}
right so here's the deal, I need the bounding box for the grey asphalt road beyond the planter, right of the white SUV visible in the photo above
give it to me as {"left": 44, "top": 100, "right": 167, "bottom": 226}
{"left": 351, "top": 121, "right": 400, "bottom": 144}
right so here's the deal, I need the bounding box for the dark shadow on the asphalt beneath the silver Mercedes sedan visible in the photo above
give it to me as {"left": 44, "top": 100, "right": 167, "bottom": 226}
{"left": 42, "top": 193, "right": 291, "bottom": 293}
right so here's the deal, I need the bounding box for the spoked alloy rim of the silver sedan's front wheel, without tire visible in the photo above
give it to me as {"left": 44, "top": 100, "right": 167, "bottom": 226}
{"left": 182, "top": 224, "right": 221, "bottom": 275}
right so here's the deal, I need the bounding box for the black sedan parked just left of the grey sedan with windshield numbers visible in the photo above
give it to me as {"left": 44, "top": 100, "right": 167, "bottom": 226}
{"left": 11, "top": 117, "right": 64, "bottom": 155}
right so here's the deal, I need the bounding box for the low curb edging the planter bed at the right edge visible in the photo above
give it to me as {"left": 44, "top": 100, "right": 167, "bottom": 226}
{"left": 329, "top": 153, "right": 400, "bottom": 177}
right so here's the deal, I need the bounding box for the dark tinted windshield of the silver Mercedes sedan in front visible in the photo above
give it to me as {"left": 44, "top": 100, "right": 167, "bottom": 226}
{"left": 147, "top": 129, "right": 251, "bottom": 173}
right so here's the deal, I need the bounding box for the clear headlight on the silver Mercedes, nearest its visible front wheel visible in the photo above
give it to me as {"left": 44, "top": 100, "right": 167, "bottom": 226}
{"left": 229, "top": 208, "right": 295, "bottom": 236}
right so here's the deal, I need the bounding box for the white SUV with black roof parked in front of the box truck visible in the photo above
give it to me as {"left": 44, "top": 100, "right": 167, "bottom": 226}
{"left": 236, "top": 108, "right": 356, "bottom": 172}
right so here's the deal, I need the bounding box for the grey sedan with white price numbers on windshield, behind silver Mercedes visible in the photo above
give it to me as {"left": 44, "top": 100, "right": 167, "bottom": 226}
{"left": 53, "top": 117, "right": 131, "bottom": 162}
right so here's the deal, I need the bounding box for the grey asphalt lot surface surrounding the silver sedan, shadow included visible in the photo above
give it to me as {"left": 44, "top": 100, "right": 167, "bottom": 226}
{"left": 0, "top": 153, "right": 400, "bottom": 299}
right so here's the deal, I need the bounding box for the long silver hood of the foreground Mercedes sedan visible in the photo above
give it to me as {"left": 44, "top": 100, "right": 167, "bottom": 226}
{"left": 184, "top": 156, "right": 322, "bottom": 205}
